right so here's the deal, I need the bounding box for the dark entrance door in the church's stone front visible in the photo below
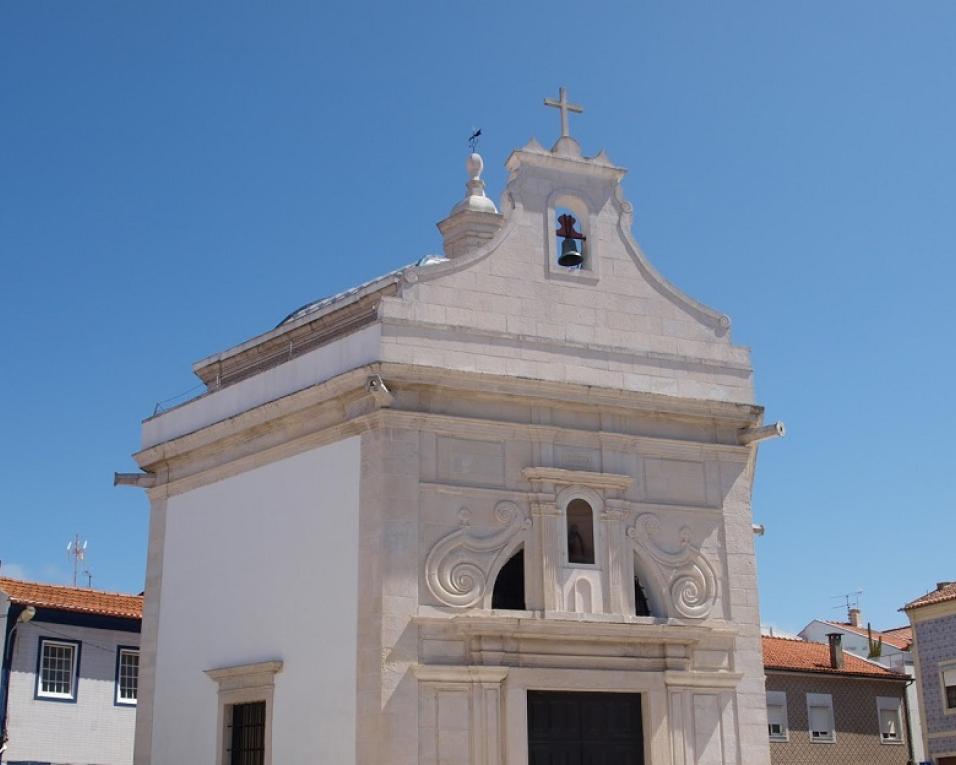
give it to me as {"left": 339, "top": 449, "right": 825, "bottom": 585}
{"left": 528, "top": 691, "right": 644, "bottom": 765}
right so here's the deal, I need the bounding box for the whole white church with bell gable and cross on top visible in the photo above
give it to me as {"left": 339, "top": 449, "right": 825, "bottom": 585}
{"left": 125, "top": 89, "right": 782, "bottom": 765}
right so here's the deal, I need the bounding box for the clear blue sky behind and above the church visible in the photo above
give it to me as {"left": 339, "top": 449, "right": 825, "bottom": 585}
{"left": 0, "top": 0, "right": 956, "bottom": 629}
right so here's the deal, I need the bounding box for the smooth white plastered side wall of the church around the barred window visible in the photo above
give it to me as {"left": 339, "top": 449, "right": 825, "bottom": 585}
{"left": 151, "top": 438, "right": 360, "bottom": 765}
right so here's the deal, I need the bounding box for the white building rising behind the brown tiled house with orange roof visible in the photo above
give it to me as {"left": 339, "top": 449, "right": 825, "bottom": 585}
{"left": 800, "top": 608, "right": 925, "bottom": 762}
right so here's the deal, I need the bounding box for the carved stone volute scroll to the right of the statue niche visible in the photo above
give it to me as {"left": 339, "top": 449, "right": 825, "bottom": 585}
{"left": 627, "top": 513, "right": 717, "bottom": 619}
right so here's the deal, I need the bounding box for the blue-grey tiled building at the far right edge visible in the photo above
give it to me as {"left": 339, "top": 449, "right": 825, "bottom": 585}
{"left": 903, "top": 582, "right": 956, "bottom": 765}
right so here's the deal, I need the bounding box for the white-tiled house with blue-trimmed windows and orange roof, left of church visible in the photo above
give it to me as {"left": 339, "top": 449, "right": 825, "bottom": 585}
{"left": 0, "top": 578, "right": 143, "bottom": 765}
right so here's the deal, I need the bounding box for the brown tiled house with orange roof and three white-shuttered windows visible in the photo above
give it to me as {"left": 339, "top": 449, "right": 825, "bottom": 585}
{"left": 763, "top": 633, "right": 913, "bottom": 765}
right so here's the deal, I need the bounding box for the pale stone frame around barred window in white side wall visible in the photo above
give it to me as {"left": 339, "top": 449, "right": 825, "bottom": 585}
{"left": 205, "top": 660, "right": 282, "bottom": 765}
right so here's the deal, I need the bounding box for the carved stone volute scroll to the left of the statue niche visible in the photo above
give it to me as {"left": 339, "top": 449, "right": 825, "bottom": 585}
{"left": 425, "top": 501, "right": 532, "bottom": 608}
